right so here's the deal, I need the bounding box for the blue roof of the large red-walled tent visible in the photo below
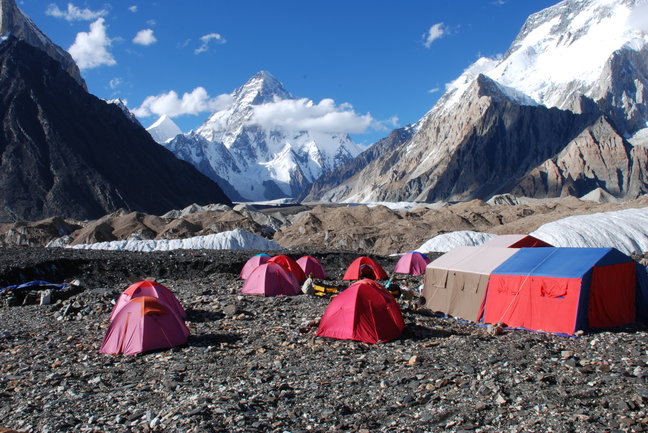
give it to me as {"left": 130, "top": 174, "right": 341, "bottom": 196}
{"left": 492, "top": 248, "right": 632, "bottom": 278}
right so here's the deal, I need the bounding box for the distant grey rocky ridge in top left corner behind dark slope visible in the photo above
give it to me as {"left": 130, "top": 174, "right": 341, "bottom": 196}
{"left": 0, "top": 0, "right": 88, "bottom": 91}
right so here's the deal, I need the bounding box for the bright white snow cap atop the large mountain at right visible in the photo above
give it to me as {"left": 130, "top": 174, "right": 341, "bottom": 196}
{"left": 437, "top": 0, "right": 648, "bottom": 120}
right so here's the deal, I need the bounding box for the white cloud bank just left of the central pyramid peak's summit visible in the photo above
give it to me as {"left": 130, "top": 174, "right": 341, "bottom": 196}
{"left": 131, "top": 87, "right": 232, "bottom": 117}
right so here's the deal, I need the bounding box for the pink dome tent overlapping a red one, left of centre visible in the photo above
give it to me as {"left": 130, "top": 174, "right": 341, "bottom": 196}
{"left": 241, "top": 262, "right": 301, "bottom": 296}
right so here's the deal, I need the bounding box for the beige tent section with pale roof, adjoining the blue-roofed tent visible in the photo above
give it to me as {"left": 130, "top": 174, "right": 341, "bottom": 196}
{"left": 423, "top": 247, "right": 518, "bottom": 322}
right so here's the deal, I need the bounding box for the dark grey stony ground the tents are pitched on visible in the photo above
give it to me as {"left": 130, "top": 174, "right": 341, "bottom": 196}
{"left": 0, "top": 248, "right": 648, "bottom": 432}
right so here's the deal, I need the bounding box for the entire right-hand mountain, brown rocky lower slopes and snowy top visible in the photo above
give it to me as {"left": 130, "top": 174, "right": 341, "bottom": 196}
{"left": 309, "top": 0, "right": 648, "bottom": 202}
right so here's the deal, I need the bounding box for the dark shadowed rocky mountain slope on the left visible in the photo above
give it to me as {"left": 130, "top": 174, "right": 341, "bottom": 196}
{"left": 0, "top": 36, "right": 230, "bottom": 221}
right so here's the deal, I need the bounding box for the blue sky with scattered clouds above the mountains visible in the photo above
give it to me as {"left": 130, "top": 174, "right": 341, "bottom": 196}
{"left": 17, "top": 0, "right": 557, "bottom": 144}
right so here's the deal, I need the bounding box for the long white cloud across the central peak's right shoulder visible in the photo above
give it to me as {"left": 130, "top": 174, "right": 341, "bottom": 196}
{"left": 250, "top": 98, "right": 380, "bottom": 134}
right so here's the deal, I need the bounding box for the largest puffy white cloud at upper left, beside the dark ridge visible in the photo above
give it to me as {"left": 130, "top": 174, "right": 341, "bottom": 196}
{"left": 68, "top": 18, "right": 117, "bottom": 69}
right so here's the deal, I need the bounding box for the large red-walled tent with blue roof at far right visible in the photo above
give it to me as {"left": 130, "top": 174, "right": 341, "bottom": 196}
{"left": 483, "top": 248, "right": 643, "bottom": 335}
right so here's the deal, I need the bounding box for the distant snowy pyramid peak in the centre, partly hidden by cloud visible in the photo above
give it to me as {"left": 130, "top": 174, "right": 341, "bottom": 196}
{"left": 163, "top": 72, "right": 362, "bottom": 201}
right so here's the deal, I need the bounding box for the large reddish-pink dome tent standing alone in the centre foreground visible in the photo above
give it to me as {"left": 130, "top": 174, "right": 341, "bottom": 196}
{"left": 317, "top": 279, "right": 405, "bottom": 344}
